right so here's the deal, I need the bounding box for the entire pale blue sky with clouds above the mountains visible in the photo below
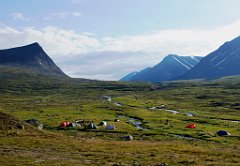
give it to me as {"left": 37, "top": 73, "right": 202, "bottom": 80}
{"left": 0, "top": 0, "right": 240, "bottom": 80}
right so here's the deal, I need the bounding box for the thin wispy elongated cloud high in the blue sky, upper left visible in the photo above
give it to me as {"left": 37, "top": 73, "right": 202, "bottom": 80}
{"left": 43, "top": 12, "right": 82, "bottom": 20}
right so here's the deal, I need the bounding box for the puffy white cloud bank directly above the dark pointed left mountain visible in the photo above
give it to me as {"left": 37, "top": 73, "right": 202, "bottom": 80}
{"left": 0, "top": 27, "right": 101, "bottom": 58}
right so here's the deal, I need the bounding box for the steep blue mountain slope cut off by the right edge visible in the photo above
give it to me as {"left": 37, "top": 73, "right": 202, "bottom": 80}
{"left": 176, "top": 36, "right": 240, "bottom": 80}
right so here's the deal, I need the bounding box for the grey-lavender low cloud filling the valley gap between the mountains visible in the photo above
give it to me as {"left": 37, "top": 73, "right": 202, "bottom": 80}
{"left": 59, "top": 51, "right": 156, "bottom": 80}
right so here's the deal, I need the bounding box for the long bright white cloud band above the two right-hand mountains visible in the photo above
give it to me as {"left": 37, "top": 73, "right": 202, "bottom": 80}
{"left": 102, "top": 22, "right": 240, "bottom": 55}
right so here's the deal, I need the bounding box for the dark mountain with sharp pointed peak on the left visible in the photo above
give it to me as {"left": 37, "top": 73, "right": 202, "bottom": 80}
{"left": 0, "top": 43, "right": 68, "bottom": 77}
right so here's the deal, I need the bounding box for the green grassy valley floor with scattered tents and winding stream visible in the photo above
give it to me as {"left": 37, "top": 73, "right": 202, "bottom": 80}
{"left": 0, "top": 75, "right": 240, "bottom": 165}
